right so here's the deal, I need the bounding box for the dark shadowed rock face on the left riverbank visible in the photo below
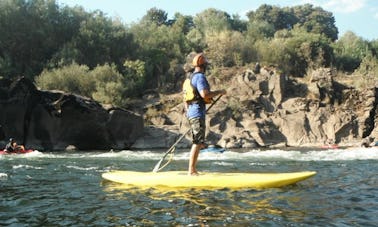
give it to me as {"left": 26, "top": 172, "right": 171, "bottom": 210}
{"left": 0, "top": 78, "right": 143, "bottom": 150}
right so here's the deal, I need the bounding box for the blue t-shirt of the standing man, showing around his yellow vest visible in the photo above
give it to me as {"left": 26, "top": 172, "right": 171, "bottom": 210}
{"left": 187, "top": 73, "right": 210, "bottom": 119}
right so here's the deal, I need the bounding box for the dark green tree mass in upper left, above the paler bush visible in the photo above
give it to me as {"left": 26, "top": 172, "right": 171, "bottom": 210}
{"left": 0, "top": 0, "right": 137, "bottom": 78}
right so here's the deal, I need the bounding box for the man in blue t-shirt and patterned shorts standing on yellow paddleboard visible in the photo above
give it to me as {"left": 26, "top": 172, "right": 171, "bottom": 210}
{"left": 184, "top": 53, "right": 226, "bottom": 175}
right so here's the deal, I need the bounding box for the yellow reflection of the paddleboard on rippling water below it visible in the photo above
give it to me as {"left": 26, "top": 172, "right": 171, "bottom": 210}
{"left": 103, "top": 181, "right": 318, "bottom": 226}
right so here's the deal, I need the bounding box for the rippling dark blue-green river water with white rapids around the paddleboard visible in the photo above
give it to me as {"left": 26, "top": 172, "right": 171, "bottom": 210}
{"left": 0, "top": 148, "right": 378, "bottom": 226}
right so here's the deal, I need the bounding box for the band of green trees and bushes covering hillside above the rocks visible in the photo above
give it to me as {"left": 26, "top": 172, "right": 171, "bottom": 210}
{"left": 0, "top": 0, "right": 378, "bottom": 106}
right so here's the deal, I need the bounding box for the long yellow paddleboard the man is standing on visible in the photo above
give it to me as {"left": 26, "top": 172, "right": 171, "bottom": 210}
{"left": 102, "top": 171, "right": 316, "bottom": 189}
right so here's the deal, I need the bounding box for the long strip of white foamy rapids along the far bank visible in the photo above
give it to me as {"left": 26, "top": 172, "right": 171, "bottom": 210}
{"left": 4, "top": 147, "right": 378, "bottom": 162}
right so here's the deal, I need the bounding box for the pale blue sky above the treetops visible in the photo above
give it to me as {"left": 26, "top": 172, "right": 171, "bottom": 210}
{"left": 57, "top": 0, "right": 378, "bottom": 41}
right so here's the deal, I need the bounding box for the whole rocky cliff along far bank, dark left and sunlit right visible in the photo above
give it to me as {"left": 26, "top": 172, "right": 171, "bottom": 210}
{"left": 0, "top": 68, "right": 378, "bottom": 150}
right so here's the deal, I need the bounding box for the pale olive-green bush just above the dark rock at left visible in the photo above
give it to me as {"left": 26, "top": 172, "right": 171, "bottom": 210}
{"left": 36, "top": 63, "right": 136, "bottom": 107}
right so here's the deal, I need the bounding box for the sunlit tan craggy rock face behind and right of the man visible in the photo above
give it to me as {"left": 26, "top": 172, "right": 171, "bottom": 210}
{"left": 136, "top": 68, "right": 378, "bottom": 148}
